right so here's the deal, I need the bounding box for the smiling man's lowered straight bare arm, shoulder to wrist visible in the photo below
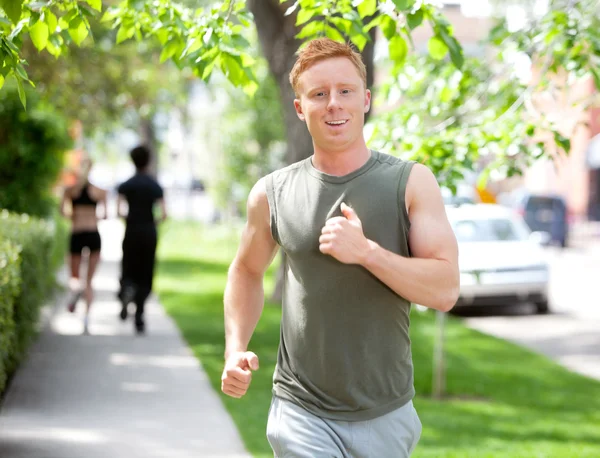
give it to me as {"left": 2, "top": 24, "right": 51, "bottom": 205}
{"left": 225, "top": 179, "right": 277, "bottom": 359}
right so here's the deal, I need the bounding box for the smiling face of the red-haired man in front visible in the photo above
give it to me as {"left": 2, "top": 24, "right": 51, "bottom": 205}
{"left": 294, "top": 57, "right": 371, "bottom": 151}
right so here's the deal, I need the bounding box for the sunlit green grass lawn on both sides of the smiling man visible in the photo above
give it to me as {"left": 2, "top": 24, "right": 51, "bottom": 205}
{"left": 156, "top": 223, "right": 600, "bottom": 458}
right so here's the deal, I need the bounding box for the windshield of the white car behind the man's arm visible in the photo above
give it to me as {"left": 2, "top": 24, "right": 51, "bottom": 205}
{"left": 452, "top": 218, "right": 529, "bottom": 242}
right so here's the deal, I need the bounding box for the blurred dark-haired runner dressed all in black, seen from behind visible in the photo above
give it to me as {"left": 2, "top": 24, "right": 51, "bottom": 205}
{"left": 117, "top": 146, "right": 167, "bottom": 333}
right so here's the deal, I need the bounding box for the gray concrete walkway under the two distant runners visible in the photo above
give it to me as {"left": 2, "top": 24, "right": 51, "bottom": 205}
{"left": 0, "top": 221, "right": 249, "bottom": 458}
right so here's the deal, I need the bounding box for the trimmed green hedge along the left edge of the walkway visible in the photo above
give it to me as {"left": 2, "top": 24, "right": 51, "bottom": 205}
{"left": 0, "top": 210, "right": 67, "bottom": 391}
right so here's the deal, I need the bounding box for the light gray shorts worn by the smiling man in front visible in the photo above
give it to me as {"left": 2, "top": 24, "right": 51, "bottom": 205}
{"left": 267, "top": 396, "right": 421, "bottom": 458}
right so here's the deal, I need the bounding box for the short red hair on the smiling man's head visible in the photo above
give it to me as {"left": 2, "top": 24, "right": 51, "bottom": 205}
{"left": 290, "top": 38, "right": 367, "bottom": 95}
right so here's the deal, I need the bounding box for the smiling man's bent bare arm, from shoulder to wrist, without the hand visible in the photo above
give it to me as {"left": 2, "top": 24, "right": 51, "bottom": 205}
{"left": 364, "top": 164, "right": 460, "bottom": 311}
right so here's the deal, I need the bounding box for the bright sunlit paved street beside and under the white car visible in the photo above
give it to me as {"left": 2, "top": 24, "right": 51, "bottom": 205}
{"left": 459, "top": 244, "right": 600, "bottom": 380}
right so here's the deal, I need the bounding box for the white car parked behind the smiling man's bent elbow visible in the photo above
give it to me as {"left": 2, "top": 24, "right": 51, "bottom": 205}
{"left": 446, "top": 204, "right": 549, "bottom": 313}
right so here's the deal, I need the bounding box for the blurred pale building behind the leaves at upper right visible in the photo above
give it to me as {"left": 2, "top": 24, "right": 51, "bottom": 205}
{"left": 390, "top": 0, "right": 600, "bottom": 220}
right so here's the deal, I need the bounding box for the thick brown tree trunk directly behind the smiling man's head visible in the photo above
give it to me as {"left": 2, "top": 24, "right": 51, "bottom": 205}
{"left": 248, "top": 0, "right": 375, "bottom": 303}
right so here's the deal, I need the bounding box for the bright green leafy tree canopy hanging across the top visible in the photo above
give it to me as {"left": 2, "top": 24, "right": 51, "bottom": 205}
{"left": 0, "top": 0, "right": 600, "bottom": 187}
